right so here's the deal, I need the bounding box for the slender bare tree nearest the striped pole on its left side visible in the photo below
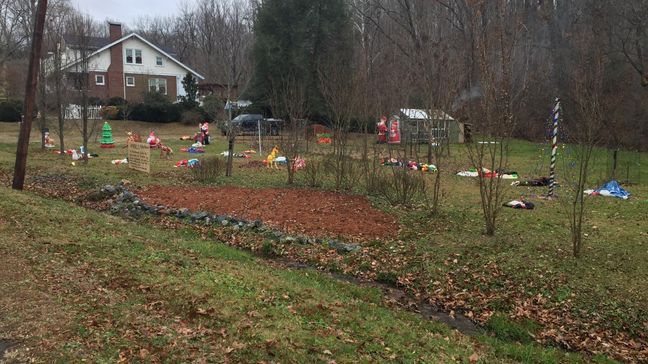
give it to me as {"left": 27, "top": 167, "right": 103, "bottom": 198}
{"left": 466, "top": 0, "right": 525, "bottom": 235}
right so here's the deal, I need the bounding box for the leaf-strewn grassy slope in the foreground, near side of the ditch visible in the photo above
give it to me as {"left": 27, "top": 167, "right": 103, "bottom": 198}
{"left": 0, "top": 187, "right": 596, "bottom": 363}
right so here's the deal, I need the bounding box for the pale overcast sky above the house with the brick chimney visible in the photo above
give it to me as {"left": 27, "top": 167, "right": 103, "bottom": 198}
{"left": 72, "top": 0, "right": 186, "bottom": 27}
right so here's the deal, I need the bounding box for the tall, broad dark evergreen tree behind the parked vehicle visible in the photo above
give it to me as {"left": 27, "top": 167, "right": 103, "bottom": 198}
{"left": 243, "top": 0, "right": 352, "bottom": 118}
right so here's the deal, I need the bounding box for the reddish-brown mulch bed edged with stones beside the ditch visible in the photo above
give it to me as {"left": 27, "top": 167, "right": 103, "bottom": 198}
{"left": 137, "top": 186, "right": 398, "bottom": 241}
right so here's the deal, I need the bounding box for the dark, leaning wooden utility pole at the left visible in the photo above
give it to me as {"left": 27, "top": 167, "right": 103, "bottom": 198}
{"left": 12, "top": 0, "right": 47, "bottom": 190}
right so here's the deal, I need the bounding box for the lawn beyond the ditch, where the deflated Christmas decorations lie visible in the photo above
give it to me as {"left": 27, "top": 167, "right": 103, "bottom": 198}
{"left": 0, "top": 122, "right": 648, "bottom": 362}
